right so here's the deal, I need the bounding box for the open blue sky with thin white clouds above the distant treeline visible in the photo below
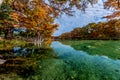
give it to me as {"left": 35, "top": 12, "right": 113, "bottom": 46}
{"left": 54, "top": 0, "right": 113, "bottom": 36}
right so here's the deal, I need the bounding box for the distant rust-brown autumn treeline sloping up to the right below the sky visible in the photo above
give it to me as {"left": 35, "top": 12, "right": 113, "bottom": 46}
{"left": 58, "top": 20, "right": 120, "bottom": 40}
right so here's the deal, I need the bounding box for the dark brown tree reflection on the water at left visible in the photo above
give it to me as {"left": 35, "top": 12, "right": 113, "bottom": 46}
{"left": 0, "top": 44, "right": 56, "bottom": 79}
